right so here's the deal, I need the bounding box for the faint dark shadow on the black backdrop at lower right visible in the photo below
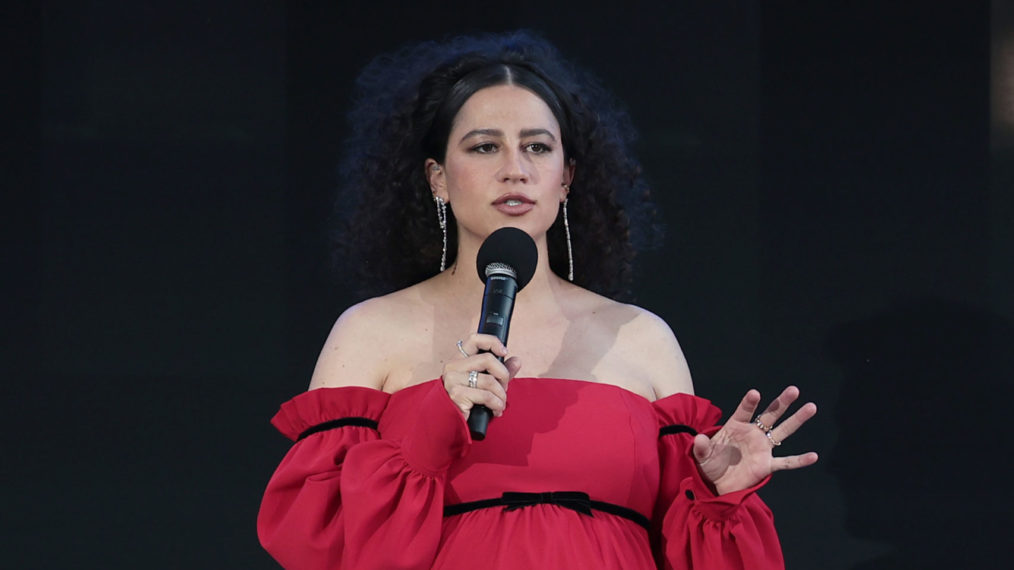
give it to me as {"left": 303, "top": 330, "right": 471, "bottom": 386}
{"left": 827, "top": 300, "right": 1014, "bottom": 570}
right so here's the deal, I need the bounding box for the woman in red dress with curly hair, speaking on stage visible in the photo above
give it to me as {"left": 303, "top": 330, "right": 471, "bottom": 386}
{"left": 259, "top": 33, "right": 816, "bottom": 569}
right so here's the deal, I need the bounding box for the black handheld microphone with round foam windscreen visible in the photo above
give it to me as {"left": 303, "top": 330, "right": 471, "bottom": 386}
{"left": 468, "top": 227, "right": 538, "bottom": 441}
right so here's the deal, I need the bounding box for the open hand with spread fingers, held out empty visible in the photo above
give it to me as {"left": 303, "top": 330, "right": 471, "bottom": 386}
{"left": 694, "top": 386, "right": 817, "bottom": 495}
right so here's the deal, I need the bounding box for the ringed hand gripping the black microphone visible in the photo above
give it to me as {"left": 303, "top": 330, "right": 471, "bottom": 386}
{"left": 441, "top": 333, "right": 521, "bottom": 419}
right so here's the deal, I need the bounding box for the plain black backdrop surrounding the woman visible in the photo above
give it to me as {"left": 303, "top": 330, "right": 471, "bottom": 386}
{"left": 0, "top": 0, "right": 1014, "bottom": 569}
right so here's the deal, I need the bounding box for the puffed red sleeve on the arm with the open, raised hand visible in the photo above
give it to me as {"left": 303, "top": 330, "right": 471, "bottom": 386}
{"left": 655, "top": 394, "right": 785, "bottom": 570}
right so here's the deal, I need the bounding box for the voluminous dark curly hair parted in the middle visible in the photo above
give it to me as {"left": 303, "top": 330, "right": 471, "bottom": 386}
{"left": 336, "top": 30, "right": 658, "bottom": 299}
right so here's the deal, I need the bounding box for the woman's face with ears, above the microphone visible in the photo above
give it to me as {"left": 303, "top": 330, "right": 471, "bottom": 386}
{"left": 426, "top": 85, "right": 573, "bottom": 244}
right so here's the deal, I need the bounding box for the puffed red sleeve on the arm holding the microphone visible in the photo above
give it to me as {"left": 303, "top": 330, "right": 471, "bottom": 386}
{"left": 258, "top": 380, "right": 470, "bottom": 570}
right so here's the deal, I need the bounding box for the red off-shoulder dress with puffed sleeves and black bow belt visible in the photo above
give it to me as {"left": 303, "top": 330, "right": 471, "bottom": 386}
{"left": 258, "top": 378, "right": 784, "bottom": 570}
